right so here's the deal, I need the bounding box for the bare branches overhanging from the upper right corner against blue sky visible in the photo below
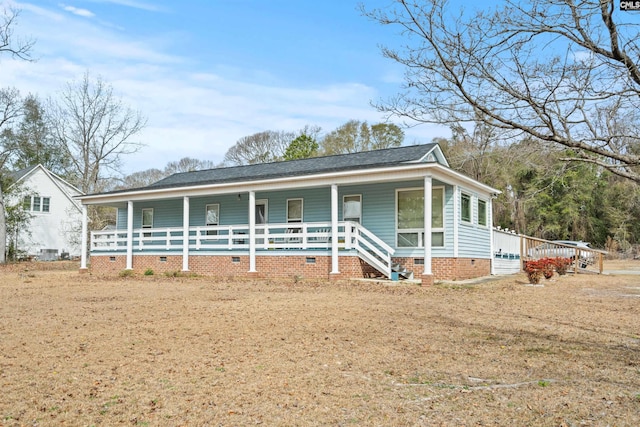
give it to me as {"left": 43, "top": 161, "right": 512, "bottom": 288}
{"left": 364, "top": 0, "right": 640, "bottom": 182}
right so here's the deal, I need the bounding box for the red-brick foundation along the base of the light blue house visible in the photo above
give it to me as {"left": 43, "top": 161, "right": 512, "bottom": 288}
{"left": 91, "top": 254, "right": 491, "bottom": 284}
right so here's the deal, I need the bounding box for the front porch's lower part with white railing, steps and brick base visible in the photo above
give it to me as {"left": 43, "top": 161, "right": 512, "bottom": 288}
{"left": 90, "top": 221, "right": 424, "bottom": 279}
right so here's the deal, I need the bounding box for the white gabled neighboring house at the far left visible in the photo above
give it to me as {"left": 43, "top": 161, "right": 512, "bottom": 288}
{"left": 12, "top": 164, "right": 82, "bottom": 261}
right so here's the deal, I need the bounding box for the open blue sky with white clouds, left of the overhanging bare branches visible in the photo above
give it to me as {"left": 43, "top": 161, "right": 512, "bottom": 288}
{"left": 0, "top": 0, "right": 449, "bottom": 173}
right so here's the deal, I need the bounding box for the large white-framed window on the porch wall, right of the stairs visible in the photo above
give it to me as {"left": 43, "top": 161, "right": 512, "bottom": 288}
{"left": 396, "top": 187, "right": 444, "bottom": 247}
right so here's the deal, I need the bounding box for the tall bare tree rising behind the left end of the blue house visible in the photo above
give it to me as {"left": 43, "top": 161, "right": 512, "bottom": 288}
{"left": 48, "top": 73, "right": 146, "bottom": 193}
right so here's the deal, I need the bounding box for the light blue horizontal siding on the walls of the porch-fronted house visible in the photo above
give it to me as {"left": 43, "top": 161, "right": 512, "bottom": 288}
{"left": 110, "top": 179, "right": 491, "bottom": 258}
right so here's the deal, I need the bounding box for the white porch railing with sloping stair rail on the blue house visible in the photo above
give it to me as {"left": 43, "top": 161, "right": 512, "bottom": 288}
{"left": 90, "top": 221, "right": 394, "bottom": 277}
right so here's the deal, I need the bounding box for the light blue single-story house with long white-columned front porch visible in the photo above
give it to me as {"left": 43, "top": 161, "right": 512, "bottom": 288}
{"left": 79, "top": 144, "right": 498, "bottom": 283}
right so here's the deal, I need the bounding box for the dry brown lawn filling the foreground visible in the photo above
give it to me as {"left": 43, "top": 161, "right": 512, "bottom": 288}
{"left": 0, "top": 263, "right": 640, "bottom": 426}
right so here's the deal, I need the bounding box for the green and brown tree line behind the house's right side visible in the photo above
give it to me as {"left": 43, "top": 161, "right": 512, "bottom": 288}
{"left": 434, "top": 122, "right": 640, "bottom": 254}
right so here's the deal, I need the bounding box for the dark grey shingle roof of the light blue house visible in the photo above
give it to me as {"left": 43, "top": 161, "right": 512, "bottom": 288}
{"left": 145, "top": 144, "right": 437, "bottom": 189}
